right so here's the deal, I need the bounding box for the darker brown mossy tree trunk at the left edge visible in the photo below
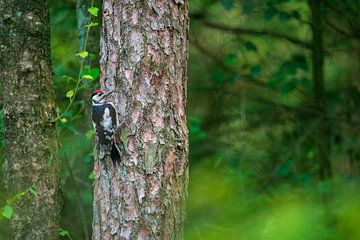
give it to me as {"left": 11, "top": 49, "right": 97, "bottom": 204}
{"left": 0, "top": 0, "right": 60, "bottom": 240}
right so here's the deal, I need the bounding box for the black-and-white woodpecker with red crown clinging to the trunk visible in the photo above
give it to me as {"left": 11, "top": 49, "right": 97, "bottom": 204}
{"left": 91, "top": 90, "right": 120, "bottom": 165}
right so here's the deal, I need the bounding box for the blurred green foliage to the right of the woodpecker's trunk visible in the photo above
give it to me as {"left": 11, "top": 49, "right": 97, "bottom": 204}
{"left": 185, "top": 0, "right": 360, "bottom": 240}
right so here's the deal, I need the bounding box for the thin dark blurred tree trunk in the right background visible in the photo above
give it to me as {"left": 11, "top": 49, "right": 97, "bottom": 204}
{"left": 309, "top": 0, "right": 331, "bottom": 179}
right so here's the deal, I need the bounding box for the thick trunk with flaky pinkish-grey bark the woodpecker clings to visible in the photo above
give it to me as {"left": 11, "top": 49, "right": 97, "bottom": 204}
{"left": 93, "top": 0, "right": 188, "bottom": 240}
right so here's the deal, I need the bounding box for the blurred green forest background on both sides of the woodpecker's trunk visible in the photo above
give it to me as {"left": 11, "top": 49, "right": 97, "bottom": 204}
{"left": 0, "top": 0, "right": 360, "bottom": 240}
